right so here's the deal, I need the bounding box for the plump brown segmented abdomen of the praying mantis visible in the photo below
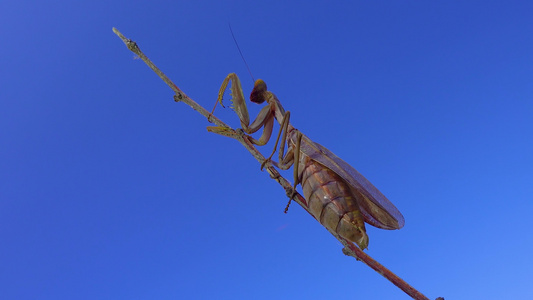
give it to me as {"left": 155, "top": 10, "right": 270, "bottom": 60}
{"left": 299, "top": 153, "right": 368, "bottom": 249}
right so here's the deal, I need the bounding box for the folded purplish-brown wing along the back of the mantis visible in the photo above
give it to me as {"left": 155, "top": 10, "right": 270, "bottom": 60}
{"left": 300, "top": 134, "right": 405, "bottom": 229}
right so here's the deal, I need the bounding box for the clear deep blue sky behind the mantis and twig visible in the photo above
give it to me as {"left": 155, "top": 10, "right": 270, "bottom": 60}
{"left": 0, "top": 0, "right": 533, "bottom": 299}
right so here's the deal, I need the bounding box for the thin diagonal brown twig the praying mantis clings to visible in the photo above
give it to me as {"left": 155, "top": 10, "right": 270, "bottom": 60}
{"left": 113, "top": 28, "right": 436, "bottom": 300}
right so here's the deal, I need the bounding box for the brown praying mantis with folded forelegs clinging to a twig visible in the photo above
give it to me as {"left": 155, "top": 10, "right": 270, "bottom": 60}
{"left": 212, "top": 73, "right": 405, "bottom": 250}
